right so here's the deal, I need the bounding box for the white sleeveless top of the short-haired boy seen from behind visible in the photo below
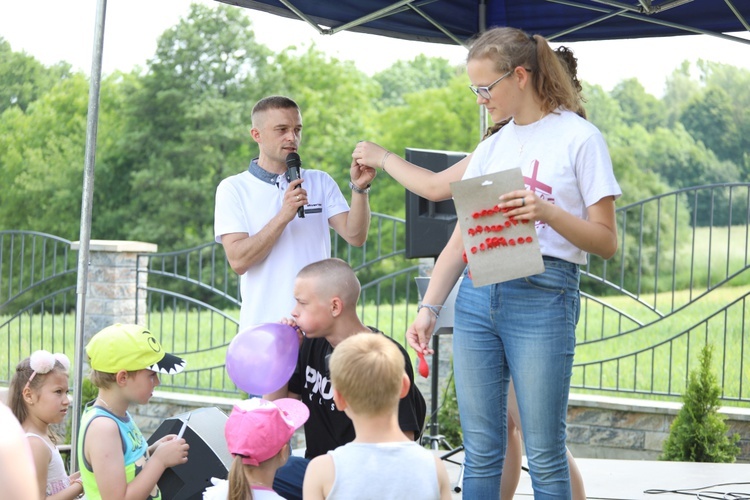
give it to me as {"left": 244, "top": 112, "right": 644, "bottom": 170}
{"left": 327, "top": 441, "right": 440, "bottom": 500}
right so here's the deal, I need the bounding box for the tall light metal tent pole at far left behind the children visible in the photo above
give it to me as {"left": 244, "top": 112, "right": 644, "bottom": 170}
{"left": 70, "top": 0, "right": 107, "bottom": 471}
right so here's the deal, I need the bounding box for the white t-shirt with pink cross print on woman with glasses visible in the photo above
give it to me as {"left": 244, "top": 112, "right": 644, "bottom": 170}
{"left": 470, "top": 110, "right": 622, "bottom": 264}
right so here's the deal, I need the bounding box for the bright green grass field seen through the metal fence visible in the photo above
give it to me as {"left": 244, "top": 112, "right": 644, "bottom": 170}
{"left": 0, "top": 286, "right": 750, "bottom": 400}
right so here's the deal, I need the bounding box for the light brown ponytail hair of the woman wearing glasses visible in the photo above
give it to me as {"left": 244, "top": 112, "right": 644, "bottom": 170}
{"left": 466, "top": 28, "right": 580, "bottom": 113}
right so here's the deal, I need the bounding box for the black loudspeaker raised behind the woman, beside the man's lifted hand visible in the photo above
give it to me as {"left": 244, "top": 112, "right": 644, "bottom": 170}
{"left": 405, "top": 148, "right": 467, "bottom": 259}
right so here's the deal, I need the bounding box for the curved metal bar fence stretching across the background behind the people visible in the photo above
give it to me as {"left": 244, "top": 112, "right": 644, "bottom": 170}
{"left": 0, "top": 184, "right": 750, "bottom": 404}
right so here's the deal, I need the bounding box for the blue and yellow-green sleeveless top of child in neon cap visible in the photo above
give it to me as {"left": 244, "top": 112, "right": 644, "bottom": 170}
{"left": 77, "top": 406, "right": 161, "bottom": 500}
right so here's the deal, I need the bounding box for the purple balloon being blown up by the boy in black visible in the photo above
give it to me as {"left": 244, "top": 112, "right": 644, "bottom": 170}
{"left": 226, "top": 323, "right": 299, "bottom": 396}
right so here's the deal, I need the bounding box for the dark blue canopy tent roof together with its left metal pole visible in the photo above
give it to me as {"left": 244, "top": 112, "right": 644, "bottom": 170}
{"left": 71, "top": 0, "right": 750, "bottom": 467}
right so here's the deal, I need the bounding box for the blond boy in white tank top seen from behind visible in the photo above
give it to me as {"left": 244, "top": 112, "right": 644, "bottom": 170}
{"left": 303, "top": 335, "right": 451, "bottom": 500}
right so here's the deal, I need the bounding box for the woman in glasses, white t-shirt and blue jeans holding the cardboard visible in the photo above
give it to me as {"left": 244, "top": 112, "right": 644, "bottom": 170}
{"left": 362, "top": 28, "right": 621, "bottom": 500}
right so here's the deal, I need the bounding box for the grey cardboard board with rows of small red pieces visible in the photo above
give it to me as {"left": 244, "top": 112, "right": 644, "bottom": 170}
{"left": 451, "top": 168, "right": 544, "bottom": 287}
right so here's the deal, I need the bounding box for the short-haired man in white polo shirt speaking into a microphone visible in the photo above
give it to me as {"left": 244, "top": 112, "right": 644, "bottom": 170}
{"left": 214, "top": 96, "right": 376, "bottom": 331}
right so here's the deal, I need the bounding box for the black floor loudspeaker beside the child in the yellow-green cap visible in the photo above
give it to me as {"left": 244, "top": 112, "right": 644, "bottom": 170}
{"left": 148, "top": 407, "right": 232, "bottom": 500}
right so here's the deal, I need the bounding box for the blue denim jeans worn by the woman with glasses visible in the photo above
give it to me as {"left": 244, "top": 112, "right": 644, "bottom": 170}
{"left": 453, "top": 257, "right": 580, "bottom": 500}
